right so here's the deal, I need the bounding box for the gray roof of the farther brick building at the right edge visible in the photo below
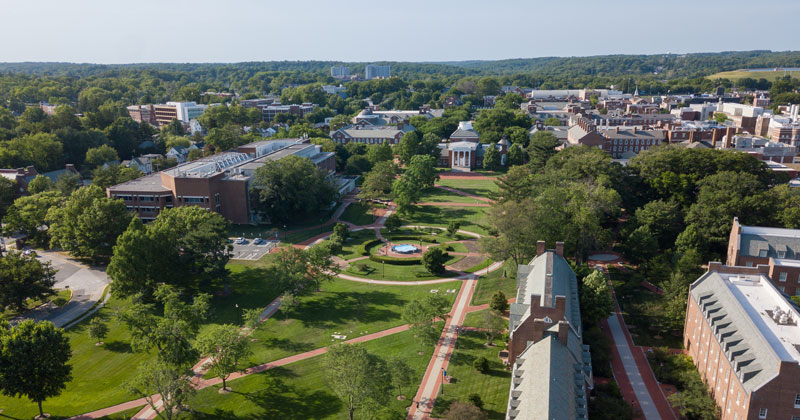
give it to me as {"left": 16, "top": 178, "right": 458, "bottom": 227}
{"left": 739, "top": 226, "right": 800, "bottom": 259}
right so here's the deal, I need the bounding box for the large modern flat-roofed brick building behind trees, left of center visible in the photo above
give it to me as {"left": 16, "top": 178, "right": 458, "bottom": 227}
{"left": 106, "top": 139, "right": 335, "bottom": 224}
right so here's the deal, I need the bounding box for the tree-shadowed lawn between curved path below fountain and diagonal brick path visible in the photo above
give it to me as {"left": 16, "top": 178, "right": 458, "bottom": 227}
{"left": 241, "top": 278, "right": 461, "bottom": 365}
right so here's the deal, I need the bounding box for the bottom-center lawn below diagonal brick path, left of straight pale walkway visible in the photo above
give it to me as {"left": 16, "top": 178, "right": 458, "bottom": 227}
{"left": 189, "top": 330, "right": 433, "bottom": 420}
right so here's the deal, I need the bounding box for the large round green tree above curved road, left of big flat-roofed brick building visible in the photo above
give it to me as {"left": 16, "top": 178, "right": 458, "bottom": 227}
{"left": 45, "top": 185, "right": 132, "bottom": 262}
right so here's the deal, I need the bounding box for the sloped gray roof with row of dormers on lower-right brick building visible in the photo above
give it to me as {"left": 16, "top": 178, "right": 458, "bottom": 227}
{"left": 689, "top": 271, "right": 800, "bottom": 393}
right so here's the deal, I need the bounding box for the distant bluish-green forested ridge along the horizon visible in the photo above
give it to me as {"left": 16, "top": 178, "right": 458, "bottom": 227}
{"left": 0, "top": 51, "right": 800, "bottom": 80}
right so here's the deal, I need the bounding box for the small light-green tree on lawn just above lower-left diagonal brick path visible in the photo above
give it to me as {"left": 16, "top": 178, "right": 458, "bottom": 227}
{"left": 197, "top": 325, "right": 252, "bottom": 389}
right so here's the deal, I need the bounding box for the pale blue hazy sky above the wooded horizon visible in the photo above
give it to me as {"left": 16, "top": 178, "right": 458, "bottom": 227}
{"left": 0, "top": 0, "right": 800, "bottom": 64}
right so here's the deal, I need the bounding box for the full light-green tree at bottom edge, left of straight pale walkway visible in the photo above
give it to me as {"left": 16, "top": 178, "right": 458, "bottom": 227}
{"left": 325, "top": 343, "right": 391, "bottom": 420}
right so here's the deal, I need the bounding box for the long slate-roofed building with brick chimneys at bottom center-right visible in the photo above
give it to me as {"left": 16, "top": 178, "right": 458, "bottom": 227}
{"left": 506, "top": 241, "right": 593, "bottom": 420}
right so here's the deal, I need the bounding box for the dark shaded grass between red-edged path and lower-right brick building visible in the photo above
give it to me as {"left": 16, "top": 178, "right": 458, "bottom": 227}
{"left": 608, "top": 267, "right": 683, "bottom": 349}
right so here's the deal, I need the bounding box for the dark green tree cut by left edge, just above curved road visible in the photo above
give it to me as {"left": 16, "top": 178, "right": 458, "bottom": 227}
{"left": 0, "top": 251, "right": 56, "bottom": 311}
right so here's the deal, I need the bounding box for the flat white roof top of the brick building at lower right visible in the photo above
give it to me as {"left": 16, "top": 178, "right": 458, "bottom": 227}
{"left": 719, "top": 273, "right": 800, "bottom": 362}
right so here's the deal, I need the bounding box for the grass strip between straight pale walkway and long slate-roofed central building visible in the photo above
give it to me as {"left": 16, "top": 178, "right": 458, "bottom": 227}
{"left": 432, "top": 331, "right": 511, "bottom": 419}
